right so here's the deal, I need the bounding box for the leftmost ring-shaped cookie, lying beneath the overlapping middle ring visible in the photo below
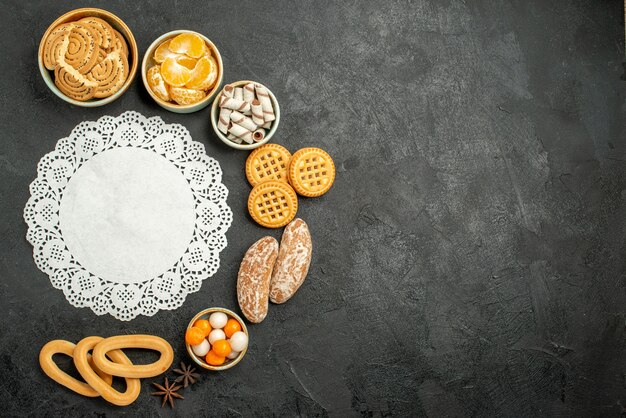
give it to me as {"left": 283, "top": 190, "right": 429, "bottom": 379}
{"left": 39, "top": 340, "right": 113, "bottom": 398}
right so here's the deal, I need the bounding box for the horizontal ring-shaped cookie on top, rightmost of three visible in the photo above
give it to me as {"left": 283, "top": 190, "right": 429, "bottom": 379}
{"left": 93, "top": 334, "right": 174, "bottom": 378}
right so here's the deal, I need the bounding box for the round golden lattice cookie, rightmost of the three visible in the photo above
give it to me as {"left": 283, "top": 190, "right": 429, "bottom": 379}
{"left": 289, "top": 148, "right": 335, "bottom": 197}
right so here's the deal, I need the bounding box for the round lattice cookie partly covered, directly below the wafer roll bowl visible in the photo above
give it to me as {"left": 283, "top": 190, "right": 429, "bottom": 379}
{"left": 246, "top": 144, "right": 291, "bottom": 186}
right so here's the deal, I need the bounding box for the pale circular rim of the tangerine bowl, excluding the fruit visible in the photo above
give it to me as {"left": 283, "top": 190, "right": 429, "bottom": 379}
{"left": 141, "top": 29, "right": 224, "bottom": 111}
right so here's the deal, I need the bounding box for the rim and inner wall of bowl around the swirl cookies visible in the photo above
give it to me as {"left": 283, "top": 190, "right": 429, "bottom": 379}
{"left": 37, "top": 7, "right": 138, "bottom": 107}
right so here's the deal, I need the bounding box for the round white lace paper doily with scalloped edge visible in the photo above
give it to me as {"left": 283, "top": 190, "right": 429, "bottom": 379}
{"left": 24, "top": 112, "right": 233, "bottom": 320}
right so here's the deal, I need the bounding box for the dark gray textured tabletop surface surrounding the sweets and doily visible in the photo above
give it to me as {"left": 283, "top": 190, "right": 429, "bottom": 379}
{"left": 0, "top": 0, "right": 626, "bottom": 417}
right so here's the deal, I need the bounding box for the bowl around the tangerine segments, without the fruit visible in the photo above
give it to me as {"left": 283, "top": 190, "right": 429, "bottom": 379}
{"left": 141, "top": 30, "right": 224, "bottom": 113}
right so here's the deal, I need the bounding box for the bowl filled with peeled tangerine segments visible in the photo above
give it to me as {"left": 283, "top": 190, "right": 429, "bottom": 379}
{"left": 141, "top": 30, "right": 223, "bottom": 113}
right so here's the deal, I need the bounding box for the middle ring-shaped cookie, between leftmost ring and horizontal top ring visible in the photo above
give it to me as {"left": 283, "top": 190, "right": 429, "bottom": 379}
{"left": 74, "top": 336, "right": 141, "bottom": 406}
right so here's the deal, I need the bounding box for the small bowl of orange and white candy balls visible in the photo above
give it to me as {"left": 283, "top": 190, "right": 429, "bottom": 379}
{"left": 185, "top": 308, "right": 249, "bottom": 371}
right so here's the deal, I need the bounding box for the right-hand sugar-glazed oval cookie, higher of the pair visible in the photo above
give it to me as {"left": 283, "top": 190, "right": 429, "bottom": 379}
{"left": 270, "top": 218, "right": 313, "bottom": 303}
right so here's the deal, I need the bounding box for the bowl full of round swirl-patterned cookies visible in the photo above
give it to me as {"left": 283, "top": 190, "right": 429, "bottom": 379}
{"left": 38, "top": 8, "right": 138, "bottom": 107}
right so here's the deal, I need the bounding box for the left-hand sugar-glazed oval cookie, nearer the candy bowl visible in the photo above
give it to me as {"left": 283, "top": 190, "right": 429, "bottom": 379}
{"left": 237, "top": 237, "right": 278, "bottom": 324}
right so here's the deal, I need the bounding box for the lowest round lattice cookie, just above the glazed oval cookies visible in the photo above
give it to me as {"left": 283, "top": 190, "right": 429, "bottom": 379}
{"left": 248, "top": 180, "right": 298, "bottom": 228}
